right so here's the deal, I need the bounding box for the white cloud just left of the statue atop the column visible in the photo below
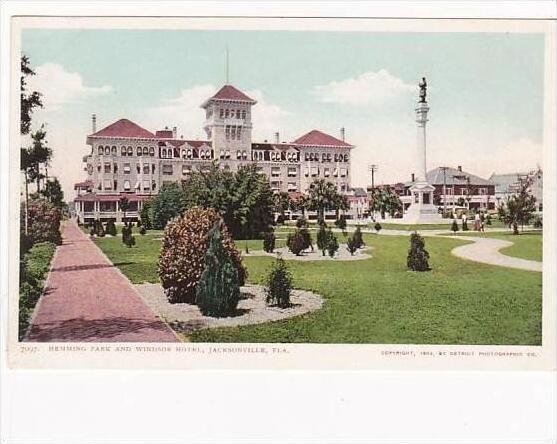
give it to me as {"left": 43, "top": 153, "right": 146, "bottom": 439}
{"left": 313, "top": 69, "right": 416, "bottom": 105}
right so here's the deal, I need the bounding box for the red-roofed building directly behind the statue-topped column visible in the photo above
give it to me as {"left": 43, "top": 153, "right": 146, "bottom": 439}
{"left": 391, "top": 166, "right": 495, "bottom": 210}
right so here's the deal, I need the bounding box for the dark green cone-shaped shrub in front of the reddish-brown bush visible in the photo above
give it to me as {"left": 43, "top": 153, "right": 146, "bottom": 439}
{"left": 195, "top": 222, "right": 240, "bottom": 317}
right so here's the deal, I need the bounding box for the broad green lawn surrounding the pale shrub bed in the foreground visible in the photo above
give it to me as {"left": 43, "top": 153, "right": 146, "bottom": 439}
{"left": 95, "top": 231, "right": 542, "bottom": 345}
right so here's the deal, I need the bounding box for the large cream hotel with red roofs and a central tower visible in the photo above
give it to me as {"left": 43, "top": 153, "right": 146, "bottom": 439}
{"left": 75, "top": 85, "right": 354, "bottom": 221}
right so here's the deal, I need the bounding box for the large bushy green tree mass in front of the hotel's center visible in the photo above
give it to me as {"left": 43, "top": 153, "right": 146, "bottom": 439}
{"left": 183, "top": 164, "right": 275, "bottom": 239}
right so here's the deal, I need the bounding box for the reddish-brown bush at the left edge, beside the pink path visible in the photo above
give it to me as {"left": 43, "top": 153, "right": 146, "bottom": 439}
{"left": 20, "top": 198, "right": 62, "bottom": 251}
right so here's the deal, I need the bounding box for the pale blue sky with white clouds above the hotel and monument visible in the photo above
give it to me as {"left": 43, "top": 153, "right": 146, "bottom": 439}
{"left": 22, "top": 29, "right": 544, "bottom": 198}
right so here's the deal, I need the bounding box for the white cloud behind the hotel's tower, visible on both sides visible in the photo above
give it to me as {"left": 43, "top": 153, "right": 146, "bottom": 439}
{"left": 142, "top": 84, "right": 291, "bottom": 140}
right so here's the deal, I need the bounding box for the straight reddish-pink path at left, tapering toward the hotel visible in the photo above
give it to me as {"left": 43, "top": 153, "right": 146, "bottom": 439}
{"left": 25, "top": 221, "right": 179, "bottom": 342}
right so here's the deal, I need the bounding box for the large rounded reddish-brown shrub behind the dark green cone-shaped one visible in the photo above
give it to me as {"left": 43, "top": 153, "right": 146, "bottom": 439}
{"left": 157, "top": 207, "right": 243, "bottom": 303}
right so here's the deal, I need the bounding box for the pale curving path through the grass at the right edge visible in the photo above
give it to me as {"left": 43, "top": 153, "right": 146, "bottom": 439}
{"left": 450, "top": 236, "right": 543, "bottom": 272}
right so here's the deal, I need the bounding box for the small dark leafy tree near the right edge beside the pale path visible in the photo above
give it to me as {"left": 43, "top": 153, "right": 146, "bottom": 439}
{"left": 497, "top": 177, "right": 536, "bottom": 234}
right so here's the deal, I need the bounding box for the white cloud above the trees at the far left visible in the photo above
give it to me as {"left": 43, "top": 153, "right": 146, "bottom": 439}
{"left": 28, "top": 63, "right": 112, "bottom": 110}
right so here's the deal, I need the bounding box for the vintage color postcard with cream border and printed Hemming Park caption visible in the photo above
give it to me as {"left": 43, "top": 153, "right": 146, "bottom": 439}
{"left": 8, "top": 16, "right": 557, "bottom": 370}
